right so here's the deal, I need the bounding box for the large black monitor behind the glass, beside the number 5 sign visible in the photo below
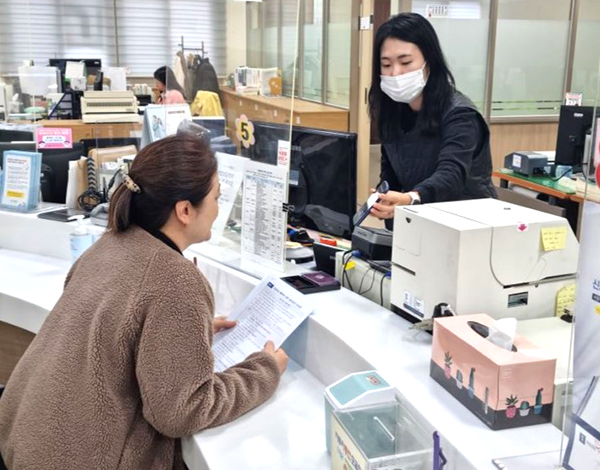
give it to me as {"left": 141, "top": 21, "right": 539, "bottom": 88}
{"left": 242, "top": 122, "right": 356, "bottom": 238}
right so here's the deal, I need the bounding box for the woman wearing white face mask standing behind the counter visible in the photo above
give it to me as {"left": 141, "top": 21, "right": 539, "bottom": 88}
{"left": 369, "top": 13, "right": 497, "bottom": 222}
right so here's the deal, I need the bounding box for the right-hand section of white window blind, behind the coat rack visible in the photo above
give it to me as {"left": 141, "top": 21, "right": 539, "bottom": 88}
{"left": 115, "top": 0, "right": 227, "bottom": 75}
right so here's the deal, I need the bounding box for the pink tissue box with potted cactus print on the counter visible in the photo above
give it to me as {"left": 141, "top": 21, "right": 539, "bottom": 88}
{"left": 430, "top": 314, "right": 556, "bottom": 429}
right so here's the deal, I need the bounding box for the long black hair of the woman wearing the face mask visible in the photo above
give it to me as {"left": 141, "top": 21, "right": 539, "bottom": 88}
{"left": 369, "top": 13, "right": 456, "bottom": 142}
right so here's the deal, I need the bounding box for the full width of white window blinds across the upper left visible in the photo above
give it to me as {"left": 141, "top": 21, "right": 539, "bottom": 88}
{"left": 0, "top": 0, "right": 227, "bottom": 76}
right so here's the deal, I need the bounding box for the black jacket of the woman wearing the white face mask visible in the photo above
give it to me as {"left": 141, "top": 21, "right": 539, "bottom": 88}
{"left": 381, "top": 92, "right": 498, "bottom": 203}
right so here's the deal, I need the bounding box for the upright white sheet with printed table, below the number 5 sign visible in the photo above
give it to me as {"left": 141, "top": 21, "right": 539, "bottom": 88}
{"left": 242, "top": 162, "right": 287, "bottom": 271}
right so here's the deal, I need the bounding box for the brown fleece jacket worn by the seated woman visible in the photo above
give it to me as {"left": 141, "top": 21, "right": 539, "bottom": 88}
{"left": 0, "top": 227, "right": 279, "bottom": 470}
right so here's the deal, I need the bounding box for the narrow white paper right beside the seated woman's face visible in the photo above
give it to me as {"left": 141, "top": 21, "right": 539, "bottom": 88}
{"left": 210, "top": 152, "right": 249, "bottom": 244}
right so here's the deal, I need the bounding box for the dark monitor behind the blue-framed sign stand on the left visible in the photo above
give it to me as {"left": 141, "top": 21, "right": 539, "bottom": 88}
{"left": 41, "top": 143, "right": 83, "bottom": 204}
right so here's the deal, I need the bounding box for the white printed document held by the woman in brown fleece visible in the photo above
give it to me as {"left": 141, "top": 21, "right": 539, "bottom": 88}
{"left": 213, "top": 274, "right": 315, "bottom": 372}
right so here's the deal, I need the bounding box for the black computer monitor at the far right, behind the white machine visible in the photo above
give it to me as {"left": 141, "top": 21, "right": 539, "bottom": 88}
{"left": 555, "top": 106, "right": 594, "bottom": 171}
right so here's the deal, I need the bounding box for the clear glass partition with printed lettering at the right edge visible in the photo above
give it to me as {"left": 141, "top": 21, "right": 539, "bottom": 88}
{"left": 561, "top": 46, "right": 600, "bottom": 470}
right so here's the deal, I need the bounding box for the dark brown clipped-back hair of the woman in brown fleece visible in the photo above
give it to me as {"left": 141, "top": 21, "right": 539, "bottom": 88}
{"left": 108, "top": 134, "right": 217, "bottom": 232}
